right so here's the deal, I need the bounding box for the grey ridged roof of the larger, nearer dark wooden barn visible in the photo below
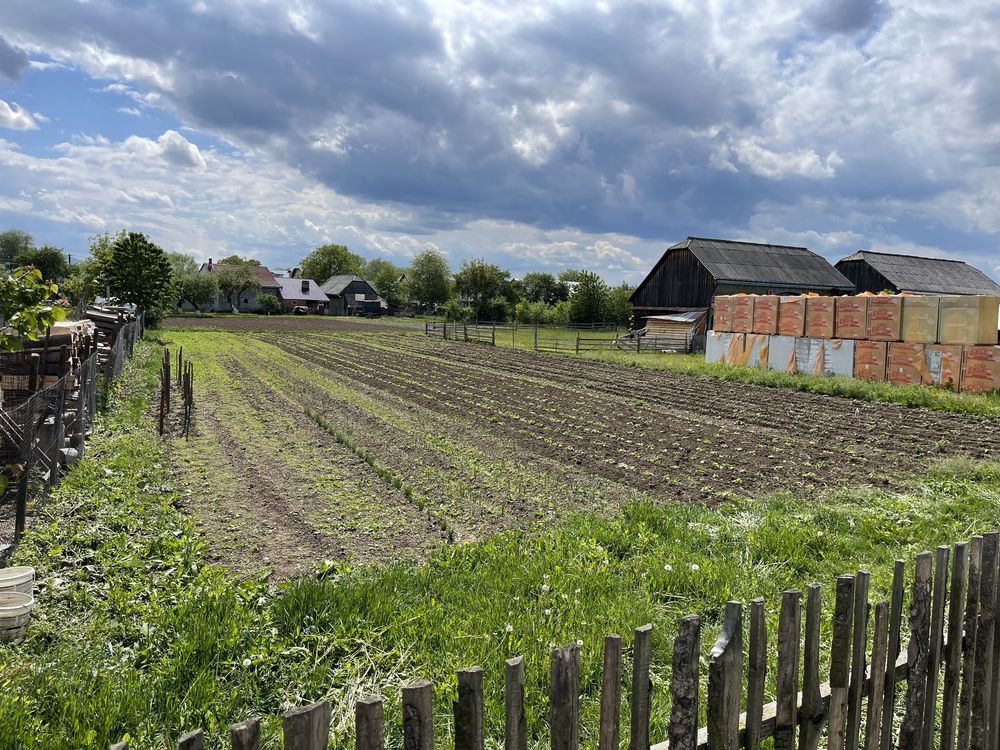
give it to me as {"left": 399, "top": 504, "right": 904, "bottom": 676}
{"left": 680, "top": 237, "right": 854, "bottom": 290}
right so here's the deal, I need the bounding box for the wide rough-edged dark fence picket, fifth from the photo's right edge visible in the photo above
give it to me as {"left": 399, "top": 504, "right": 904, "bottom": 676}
{"left": 898, "top": 552, "right": 931, "bottom": 750}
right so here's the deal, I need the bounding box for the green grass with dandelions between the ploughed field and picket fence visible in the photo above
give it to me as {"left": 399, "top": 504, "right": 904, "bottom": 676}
{"left": 0, "top": 343, "right": 1000, "bottom": 748}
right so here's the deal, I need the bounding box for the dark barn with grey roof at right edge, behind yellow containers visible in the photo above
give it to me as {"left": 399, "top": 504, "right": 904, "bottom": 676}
{"left": 837, "top": 250, "right": 1000, "bottom": 294}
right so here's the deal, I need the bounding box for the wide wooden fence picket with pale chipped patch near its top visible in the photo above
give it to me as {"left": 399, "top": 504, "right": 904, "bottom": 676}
{"left": 707, "top": 602, "right": 743, "bottom": 750}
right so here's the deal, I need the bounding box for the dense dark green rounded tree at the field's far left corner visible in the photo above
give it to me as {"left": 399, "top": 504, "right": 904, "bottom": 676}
{"left": 102, "top": 232, "right": 174, "bottom": 312}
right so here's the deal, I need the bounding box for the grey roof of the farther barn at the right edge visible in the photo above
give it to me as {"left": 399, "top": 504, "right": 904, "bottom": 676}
{"left": 837, "top": 250, "right": 1000, "bottom": 294}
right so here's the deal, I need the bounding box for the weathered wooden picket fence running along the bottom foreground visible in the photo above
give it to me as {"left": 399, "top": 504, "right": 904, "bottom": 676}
{"left": 105, "top": 532, "right": 1000, "bottom": 750}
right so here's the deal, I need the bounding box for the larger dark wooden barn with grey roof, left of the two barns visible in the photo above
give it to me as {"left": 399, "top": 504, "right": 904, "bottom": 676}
{"left": 631, "top": 237, "right": 854, "bottom": 328}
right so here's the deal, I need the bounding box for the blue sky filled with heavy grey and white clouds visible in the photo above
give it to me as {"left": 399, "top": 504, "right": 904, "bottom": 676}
{"left": 0, "top": 0, "right": 1000, "bottom": 283}
